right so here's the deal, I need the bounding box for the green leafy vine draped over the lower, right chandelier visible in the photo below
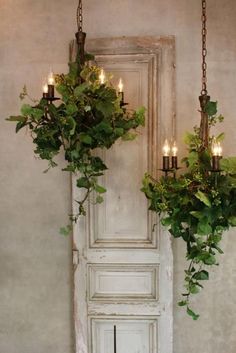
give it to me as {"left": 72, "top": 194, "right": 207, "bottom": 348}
{"left": 142, "top": 102, "right": 236, "bottom": 320}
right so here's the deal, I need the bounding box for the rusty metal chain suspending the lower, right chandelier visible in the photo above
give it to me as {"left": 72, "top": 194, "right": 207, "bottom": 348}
{"left": 201, "top": 0, "right": 207, "bottom": 95}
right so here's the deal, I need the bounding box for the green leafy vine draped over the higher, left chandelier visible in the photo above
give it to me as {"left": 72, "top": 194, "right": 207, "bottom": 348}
{"left": 7, "top": 56, "right": 145, "bottom": 235}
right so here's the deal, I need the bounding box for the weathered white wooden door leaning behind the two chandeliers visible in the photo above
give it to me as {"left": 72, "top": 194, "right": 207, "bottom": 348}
{"left": 73, "top": 37, "right": 174, "bottom": 353}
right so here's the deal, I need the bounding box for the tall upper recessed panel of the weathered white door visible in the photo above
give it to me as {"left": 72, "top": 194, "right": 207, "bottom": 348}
{"left": 90, "top": 54, "right": 157, "bottom": 248}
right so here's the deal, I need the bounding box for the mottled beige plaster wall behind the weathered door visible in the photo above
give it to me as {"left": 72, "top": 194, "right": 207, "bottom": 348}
{"left": 0, "top": 0, "right": 236, "bottom": 353}
